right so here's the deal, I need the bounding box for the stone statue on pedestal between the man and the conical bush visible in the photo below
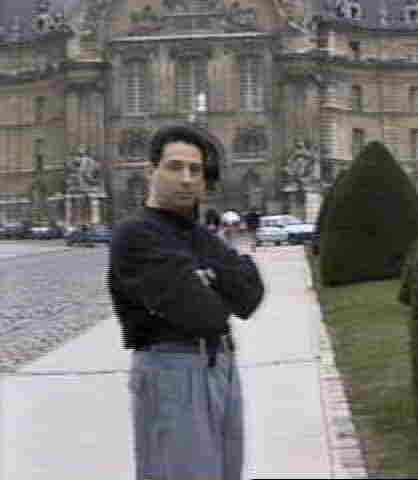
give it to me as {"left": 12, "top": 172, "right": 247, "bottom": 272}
{"left": 284, "top": 138, "right": 321, "bottom": 192}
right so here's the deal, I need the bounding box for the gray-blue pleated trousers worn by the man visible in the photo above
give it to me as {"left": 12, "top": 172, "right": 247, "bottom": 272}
{"left": 129, "top": 351, "right": 243, "bottom": 480}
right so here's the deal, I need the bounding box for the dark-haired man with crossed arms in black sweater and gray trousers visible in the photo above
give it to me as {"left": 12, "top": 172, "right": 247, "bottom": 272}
{"left": 109, "top": 126, "right": 264, "bottom": 480}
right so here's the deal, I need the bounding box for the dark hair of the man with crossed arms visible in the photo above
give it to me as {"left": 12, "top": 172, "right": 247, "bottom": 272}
{"left": 149, "top": 125, "right": 219, "bottom": 186}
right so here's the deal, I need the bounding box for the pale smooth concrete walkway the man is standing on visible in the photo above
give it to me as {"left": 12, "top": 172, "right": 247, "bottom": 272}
{"left": 0, "top": 247, "right": 352, "bottom": 480}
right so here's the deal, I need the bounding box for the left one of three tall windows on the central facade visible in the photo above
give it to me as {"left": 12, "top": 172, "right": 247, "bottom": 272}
{"left": 126, "top": 61, "right": 152, "bottom": 115}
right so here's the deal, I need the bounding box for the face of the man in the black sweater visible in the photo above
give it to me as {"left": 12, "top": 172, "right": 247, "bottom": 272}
{"left": 147, "top": 142, "right": 205, "bottom": 215}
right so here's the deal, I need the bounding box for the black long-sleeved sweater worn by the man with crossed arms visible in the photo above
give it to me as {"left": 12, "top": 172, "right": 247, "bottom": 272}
{"left": 108, "top": 208, "right": 264, "bottom": 349}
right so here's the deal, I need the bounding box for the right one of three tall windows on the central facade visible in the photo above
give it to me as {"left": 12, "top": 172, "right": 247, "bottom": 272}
{"left": 239, "top": 56, "right": 264, "bottom": 111}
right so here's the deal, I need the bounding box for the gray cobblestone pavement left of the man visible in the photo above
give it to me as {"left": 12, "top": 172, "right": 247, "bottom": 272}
{"left": 0, "top": 243, "right": 112, "bottom": 372}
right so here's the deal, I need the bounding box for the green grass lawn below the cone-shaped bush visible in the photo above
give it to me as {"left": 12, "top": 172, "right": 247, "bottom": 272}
{"left": 310, "top": 253, "right": 418, "bottom": 478}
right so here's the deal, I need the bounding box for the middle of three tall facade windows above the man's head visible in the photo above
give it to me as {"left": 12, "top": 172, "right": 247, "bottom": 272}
{"left": 176, "top": 58, "right": 208, "bottom": 111}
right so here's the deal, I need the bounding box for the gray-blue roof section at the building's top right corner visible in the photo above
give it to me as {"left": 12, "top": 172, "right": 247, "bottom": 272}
{"left": 320, "top": 0, "right": 418, "bottom": 31}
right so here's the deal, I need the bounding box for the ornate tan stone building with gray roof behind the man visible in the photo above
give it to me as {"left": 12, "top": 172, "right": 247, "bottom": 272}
{"left": 0, "top": 0, "right": 418, "bottom": 224}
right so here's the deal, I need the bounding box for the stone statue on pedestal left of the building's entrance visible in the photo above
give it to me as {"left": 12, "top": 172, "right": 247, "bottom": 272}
{"left": 66, "top": 145, "right": 101, "bottom": 193}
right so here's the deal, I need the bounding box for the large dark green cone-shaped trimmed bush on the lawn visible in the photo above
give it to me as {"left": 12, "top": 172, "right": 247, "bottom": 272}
{"left": 320, "top": 142, "right": 418, "bottom": 285}
